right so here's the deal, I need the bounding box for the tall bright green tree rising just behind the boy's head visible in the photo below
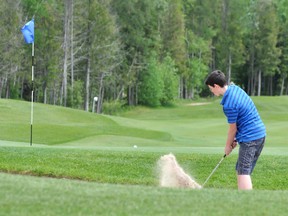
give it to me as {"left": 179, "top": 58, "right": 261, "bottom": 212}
{"left": 183, "top": 0, "right": 217, "bottom": 98}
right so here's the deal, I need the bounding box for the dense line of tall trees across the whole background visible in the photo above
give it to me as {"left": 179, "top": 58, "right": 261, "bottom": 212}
{"left": 0, "top": 0, "right": 288, "bottom": 113}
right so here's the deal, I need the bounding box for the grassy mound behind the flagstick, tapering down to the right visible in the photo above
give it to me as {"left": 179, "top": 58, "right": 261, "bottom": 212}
{"left": 0, "top": 99, "right": 171, "bottom": 145}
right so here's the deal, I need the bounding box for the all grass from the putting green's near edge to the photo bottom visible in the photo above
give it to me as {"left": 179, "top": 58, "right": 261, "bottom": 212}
{"left": 0, "top": 147, "right": 288, "bottom": 216}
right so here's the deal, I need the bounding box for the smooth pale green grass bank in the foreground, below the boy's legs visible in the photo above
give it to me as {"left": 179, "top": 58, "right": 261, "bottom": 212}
{"left": 0, "top": 173, "right": 288, "bottom": 216}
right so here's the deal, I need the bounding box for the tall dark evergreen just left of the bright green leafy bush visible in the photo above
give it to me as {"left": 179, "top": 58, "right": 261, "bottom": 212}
{"left": 111, "top": 0, "right": 163, "bottom": 105}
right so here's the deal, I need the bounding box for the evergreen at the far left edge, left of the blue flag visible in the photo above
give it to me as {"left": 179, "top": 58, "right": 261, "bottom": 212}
{"left": 0, "top": 1, "right": 23, "bottom": 99}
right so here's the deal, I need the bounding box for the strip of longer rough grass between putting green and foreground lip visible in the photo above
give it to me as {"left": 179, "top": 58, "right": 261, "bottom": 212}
{"left": 0, "top": 147, "right": 288, "bottom": 190}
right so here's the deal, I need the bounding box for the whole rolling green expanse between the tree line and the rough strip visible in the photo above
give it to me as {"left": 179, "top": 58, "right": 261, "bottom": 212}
{"left": 0, "top": 97, "right": 288, "bottom": 147}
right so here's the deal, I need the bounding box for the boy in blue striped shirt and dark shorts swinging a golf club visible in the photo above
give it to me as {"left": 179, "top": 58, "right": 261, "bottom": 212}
{"left": 205, "top": 70, "right": 266, "bottom": 190}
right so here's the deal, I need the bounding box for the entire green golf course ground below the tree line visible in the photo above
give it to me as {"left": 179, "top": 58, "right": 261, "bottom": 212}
{"left": 0, "top": 96, "right": 288, "bottom": 216}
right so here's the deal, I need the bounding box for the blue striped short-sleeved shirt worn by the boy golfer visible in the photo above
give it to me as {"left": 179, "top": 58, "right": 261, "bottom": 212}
{"left": 221, "top": 85, "right": 266, "bottom": 143}
